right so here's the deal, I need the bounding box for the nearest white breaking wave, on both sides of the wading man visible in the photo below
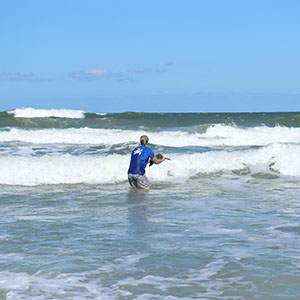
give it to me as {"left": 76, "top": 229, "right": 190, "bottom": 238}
{"left": 0, "top": 144, "right": 300, "bottom": 186}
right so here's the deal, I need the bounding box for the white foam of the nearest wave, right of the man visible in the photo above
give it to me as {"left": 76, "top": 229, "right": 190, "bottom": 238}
{"left": 147, "top": 144, "right": 300, "bottom": 180}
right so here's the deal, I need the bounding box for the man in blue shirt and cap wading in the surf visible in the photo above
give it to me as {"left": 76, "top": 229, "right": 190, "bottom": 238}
{"left": 128, "top": 135, "right": 165, "bottom": 190}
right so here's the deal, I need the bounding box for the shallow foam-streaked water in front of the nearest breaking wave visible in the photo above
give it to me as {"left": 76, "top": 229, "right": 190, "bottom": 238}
{"left": 0, "top": 179, "right": 300, "bottom": 299}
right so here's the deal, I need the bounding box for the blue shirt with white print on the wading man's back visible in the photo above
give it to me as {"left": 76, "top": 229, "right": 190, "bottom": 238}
{"left": 128, "top": 145, "right": 154, "bottom": 175}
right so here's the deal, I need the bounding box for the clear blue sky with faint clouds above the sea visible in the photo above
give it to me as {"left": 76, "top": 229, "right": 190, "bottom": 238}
{"left": 0, "top": 0, "right": 300, "bottom": 112}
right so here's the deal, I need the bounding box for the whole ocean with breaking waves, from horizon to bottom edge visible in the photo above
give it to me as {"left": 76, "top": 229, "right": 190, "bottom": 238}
{"left": 0, "top": 108, "right": 300, "bottom": 300}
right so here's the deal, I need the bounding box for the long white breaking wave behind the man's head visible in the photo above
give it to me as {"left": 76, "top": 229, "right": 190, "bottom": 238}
{"left": 0, "top": 125, "right": 300, "bottom": 147}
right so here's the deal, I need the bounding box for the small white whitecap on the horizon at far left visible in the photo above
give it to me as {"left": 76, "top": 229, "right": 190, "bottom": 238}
{"left": 9, "top": 107, "right": 85, "bottom": 119}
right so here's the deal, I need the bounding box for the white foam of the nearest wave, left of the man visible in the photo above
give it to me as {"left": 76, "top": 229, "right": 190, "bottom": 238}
{"left": 0, "top": 155, "right": 129, "bottom": 186}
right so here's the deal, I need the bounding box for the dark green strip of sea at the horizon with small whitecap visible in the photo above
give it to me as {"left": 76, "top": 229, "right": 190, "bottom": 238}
{"left": 0, "top": 107, "right": 300, "bottom": 129}
